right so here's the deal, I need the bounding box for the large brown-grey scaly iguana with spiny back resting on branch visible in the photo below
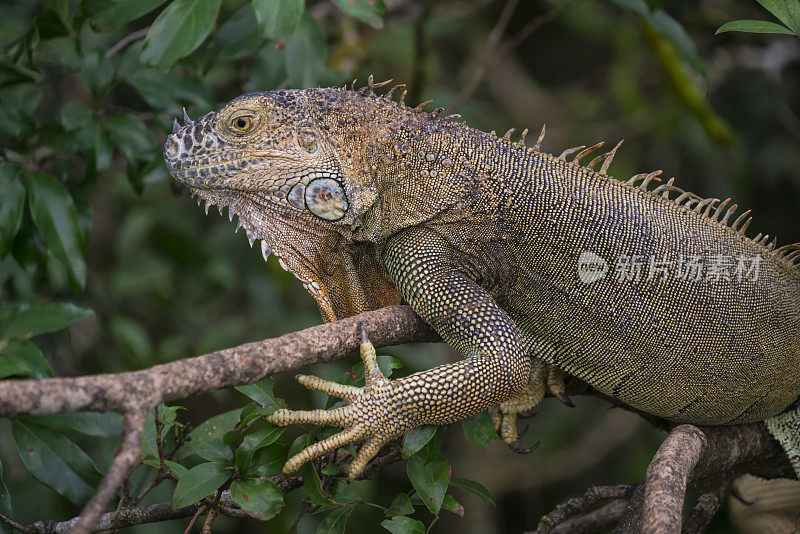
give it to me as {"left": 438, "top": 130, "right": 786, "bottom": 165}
{"left": 164, "top": 77, "right": 800, "bottom": 477}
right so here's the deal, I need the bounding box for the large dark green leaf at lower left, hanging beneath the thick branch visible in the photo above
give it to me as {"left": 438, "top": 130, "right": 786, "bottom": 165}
{"left": 11, "top": 421, "right": 100, "bottom": 504}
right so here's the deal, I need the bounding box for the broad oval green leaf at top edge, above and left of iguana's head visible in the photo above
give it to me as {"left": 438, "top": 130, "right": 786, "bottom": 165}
{"left": 142, "top": 0, "right": 222, "bottom": 69}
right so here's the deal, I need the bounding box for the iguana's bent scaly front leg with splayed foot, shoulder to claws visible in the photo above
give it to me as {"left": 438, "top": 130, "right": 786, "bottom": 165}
{"left": 269, "top": 228, "right": 531, "bottom": 478}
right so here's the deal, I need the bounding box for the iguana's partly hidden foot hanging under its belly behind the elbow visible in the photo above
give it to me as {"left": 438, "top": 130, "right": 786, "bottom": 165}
{"left": 492, "top": 359, "right": 575, "bottom": 454}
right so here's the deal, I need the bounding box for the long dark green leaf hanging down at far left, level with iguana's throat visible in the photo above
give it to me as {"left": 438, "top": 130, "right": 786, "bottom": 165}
{"left": 28, "top": 171, "right": 86, "bottom": 291}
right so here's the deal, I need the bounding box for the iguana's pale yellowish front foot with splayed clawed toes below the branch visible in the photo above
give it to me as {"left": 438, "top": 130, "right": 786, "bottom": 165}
{"left": 267, "top": 326, "right": 406, "bottom": 479}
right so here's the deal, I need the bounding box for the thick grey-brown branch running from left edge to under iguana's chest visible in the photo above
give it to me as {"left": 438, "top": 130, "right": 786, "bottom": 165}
{"left": 0, "top": 306, "right": 438, "bottom": 417}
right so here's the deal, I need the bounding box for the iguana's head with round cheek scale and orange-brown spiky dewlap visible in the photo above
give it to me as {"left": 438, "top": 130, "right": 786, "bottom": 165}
{"left": 164, "top": 90, "right": 400, "bottom": 320}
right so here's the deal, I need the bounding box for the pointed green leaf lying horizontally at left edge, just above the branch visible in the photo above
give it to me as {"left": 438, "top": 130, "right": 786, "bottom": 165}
{"left": 0, "top": 302, "right": 94, "bottom": 339}
